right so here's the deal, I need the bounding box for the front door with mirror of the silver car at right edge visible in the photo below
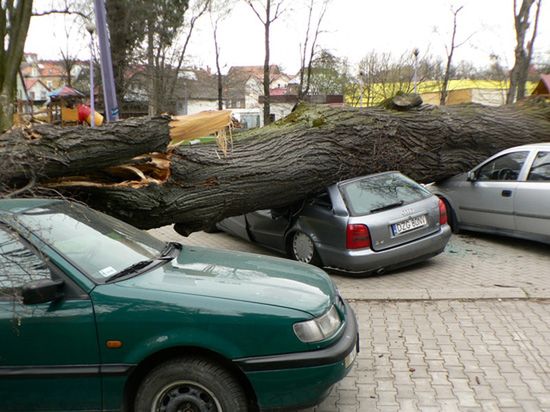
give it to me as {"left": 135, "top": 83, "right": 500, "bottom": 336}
{"left": 457, "top": 151, "right": 529, "bottom": 230}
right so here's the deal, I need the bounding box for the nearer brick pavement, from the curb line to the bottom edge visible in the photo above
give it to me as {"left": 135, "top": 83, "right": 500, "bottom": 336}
{"left": 304, "top": 300, "right": 550, "bottom": 412}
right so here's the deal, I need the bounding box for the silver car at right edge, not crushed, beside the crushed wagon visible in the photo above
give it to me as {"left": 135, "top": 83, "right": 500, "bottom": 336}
{"left": 429, "top": 143, "right": 550, "bottom": 243}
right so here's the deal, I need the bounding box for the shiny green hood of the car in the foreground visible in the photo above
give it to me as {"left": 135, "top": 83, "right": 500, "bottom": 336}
{"left": 118, "top": 246, "right": 336, "bottom": 316}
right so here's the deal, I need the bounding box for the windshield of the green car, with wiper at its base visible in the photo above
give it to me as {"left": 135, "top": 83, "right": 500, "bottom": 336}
{"left": 18, "top": 202, "right": 166, "bottom": 282}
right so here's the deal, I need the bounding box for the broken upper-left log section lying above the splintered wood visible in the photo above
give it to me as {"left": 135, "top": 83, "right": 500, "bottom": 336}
{"left": 0, "top": 116, "right": 171, "bottom": 187}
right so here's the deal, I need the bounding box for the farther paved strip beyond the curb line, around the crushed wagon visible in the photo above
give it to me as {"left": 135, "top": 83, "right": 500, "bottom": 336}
{"left": 151, "top": 226, "right": 550, "bottom": 300}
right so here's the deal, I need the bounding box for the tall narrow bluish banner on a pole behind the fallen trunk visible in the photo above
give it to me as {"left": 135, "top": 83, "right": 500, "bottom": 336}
{"left": 94, "top": 0, "right": 119, "bottom": 122}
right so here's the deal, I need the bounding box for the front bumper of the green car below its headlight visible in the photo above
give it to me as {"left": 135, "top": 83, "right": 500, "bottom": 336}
{"left": 235, "top": 303, "right": 359, "bottom": 411}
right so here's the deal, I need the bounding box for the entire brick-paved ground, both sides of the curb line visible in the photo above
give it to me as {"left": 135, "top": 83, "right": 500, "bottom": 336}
{"left": 152, "top": 227, "right": 550, "bottom": 412}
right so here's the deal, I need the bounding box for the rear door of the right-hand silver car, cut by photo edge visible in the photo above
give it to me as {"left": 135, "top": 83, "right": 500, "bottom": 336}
{"left": 515, "top": 150, "right": 550, "bottom": 240}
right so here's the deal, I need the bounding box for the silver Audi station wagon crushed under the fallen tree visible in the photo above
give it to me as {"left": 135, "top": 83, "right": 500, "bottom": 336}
{"left": 218, "top": 172, "right": 451, "bottom": 274}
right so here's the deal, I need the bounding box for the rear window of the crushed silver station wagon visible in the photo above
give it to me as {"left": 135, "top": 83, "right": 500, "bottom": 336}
{"left": 338, "top": 173, "right": 432, "bottom": 216}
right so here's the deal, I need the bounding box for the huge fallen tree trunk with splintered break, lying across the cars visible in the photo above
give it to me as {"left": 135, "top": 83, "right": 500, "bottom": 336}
{"left": 0, "top": 98, "right": 550, "bottom": 234}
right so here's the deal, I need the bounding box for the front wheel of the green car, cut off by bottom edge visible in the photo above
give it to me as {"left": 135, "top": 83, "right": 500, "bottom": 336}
{"left": 134, "top": 357, "right": 248, "bottom": 412}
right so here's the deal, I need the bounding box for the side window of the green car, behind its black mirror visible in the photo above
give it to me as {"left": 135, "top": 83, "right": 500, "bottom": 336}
{"left": 0, "top": 227, "right": 51, "bottom": 300}
